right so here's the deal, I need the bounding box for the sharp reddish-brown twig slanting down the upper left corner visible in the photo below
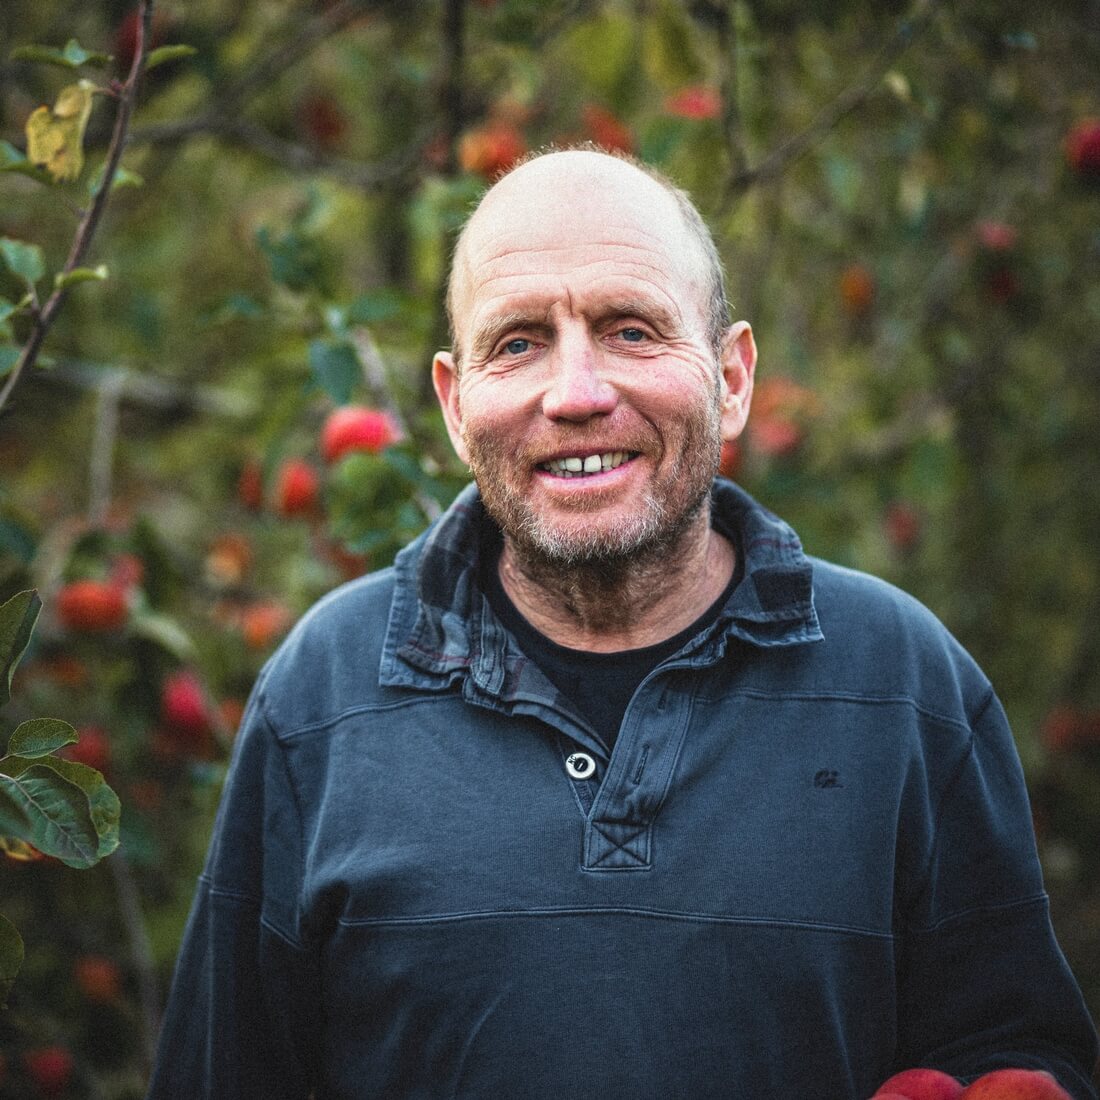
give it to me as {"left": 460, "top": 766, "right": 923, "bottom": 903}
{"left": 0, "top": 0, "right": 154, "bottom": 411}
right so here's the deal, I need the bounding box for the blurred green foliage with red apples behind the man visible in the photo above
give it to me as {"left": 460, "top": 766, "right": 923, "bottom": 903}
{"left": 0, "top": 0, "right": 1100, "bottom": 1100}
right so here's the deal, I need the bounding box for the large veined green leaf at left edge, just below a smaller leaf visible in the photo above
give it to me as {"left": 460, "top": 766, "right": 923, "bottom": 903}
{"left": 0, "top": 757, "right": 100, "bottom": 868}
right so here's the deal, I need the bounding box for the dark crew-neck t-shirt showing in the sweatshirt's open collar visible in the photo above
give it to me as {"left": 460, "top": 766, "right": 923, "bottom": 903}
{"left": 481, "top": 534, "right": 741, "bottom": 751}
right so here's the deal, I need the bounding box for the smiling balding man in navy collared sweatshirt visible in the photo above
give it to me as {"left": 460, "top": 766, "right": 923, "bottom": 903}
{"left": 151, "top": 150, "right": 1096, "bottom": 1100}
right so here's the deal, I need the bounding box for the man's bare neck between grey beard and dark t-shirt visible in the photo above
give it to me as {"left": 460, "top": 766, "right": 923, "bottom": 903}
{"left": 498, "top": 509, "right": 735, "bottom": 653}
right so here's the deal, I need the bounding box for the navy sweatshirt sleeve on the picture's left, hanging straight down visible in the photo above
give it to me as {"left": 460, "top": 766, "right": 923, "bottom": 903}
{"left": 149, "top": 681, "right": 320, "bottom": 1100}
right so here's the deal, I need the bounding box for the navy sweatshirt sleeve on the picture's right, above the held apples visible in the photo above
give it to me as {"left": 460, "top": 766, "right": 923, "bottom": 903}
{"left": 898, "top": 692, "right": 1097, "bottom": 1100}
